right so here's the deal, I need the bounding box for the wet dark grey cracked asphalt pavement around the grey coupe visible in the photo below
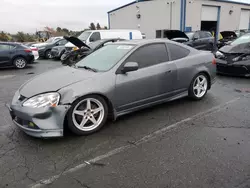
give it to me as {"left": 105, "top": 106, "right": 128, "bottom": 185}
{"left": 0, "top": 60, "right": 250, "bottom": 188}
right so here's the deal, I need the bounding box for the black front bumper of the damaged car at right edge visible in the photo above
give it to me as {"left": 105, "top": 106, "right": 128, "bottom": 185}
{"left": 216, "top": 59, "right": 250, "bottom": 77}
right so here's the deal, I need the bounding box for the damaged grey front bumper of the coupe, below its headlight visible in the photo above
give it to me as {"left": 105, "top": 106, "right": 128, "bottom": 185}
{"left": 6, "top": 102, "right": 70, "bottom": 138}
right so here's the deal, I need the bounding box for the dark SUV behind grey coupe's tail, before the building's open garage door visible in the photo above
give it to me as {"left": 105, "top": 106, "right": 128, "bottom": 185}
{"left": 186, "top": 31, "right": 214, "bottom": 51}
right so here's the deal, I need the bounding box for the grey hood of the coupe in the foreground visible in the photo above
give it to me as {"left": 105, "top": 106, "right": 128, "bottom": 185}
{"left": 19, "top": 66, "right": 95, "bottom": 98}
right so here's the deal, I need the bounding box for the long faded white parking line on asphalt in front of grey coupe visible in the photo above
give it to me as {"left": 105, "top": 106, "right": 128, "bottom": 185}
{"left": 29, "top": 97, "right": 241, "bottom": 188}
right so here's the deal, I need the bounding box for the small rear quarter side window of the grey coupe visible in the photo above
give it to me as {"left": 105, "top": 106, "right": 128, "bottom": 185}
{"left": 167, "top": 43, "right": 190, "bottom": 61}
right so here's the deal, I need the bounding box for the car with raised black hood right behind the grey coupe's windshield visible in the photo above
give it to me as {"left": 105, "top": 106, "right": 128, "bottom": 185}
{"left": 61, "top": 36, "right": 124, "bottom": 65}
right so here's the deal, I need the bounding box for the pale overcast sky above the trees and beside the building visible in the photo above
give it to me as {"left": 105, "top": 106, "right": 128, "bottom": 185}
{"left": 0, "top": 0, "right": 133, "bottom": 33}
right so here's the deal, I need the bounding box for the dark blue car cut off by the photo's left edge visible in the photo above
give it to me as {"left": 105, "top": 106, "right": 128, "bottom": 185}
{"left": 0, "top": 42, "right": 34, "bottom": 69}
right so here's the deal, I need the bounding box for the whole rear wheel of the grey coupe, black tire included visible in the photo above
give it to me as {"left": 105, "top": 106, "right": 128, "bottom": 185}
{"left": 188, "top": 73, "right": 209, "bottom": 100}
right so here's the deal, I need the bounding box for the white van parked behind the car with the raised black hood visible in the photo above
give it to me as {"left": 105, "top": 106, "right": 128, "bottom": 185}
{"left": 65, "top": 29, "right": 143, "bottom": 48}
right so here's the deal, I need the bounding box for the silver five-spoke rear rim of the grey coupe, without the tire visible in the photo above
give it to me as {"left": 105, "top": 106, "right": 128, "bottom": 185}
{"left": 193, "top": 75, "right": 208, "bottom": 98}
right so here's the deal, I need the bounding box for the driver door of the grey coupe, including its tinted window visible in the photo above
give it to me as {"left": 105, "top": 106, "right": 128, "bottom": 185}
{"left": 115, "top": 43, "right": 169, "bottom": 112}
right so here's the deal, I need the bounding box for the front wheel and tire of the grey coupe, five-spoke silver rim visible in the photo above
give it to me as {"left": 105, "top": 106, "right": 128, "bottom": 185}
{"left": 67, "top": 95, "right": 108, "bottom": 136}
